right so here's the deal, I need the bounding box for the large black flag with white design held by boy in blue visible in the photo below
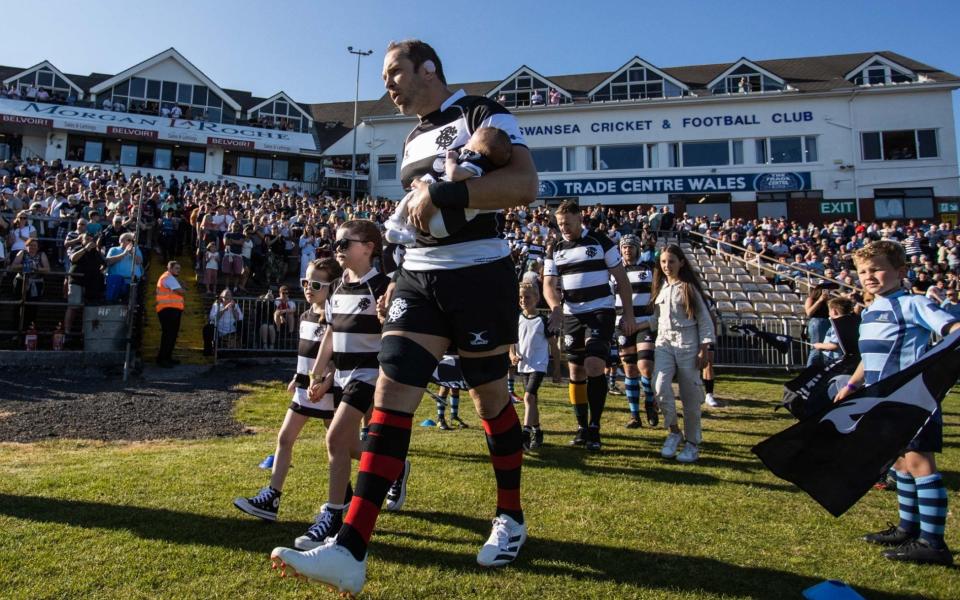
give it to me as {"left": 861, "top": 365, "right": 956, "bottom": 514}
{"left": 753, "top": 332, "right": 960, "bottom": 517}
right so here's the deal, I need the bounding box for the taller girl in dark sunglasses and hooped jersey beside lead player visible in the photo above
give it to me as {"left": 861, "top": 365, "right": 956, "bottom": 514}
{"left": 294, "top": 219, "right": 402, "bottom": 550}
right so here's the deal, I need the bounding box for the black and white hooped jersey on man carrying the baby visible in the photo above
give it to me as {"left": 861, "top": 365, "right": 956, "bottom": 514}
{"left": 400, "top": 90, "right": 526, "bottom": 271}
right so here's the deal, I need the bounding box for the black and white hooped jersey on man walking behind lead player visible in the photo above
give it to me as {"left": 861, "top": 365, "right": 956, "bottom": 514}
{"left": 543, "top": 230, "right": 621, "bottom": 315}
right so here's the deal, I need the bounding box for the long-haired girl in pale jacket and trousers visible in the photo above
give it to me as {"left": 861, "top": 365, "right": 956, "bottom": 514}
{"left": 649, "top": 244, "right": 714, "bottom": 463}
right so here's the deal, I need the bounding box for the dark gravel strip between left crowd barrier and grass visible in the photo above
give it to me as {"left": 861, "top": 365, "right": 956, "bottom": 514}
{"left": 0, "top": 361, "right": 289, "bottom": 442}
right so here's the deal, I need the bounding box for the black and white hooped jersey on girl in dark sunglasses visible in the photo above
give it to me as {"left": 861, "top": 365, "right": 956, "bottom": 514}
{"left": 326, "top": 269, "right": 390, "bottom": 388}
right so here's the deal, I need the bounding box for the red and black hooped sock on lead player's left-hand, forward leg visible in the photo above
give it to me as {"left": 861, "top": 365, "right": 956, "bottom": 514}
{"left": 337, "top": 408, "right": 413, "bottom": 560}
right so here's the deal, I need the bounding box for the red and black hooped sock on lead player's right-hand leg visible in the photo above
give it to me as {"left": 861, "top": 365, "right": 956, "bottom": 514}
{"left": 483, "top": 402, "right": 523, "bottom": 523}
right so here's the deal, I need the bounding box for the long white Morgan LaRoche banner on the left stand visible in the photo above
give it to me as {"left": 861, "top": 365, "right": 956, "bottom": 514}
{"left": 0, "top": 99, "right": 317, "bottom": 154}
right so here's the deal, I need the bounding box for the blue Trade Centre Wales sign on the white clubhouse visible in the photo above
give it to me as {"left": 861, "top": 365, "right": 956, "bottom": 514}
{"left": 538, "top": 172, "right": 811, "bottom": 198}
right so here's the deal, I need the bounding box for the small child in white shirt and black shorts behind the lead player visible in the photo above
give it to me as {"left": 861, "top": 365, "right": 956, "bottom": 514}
{"left": 510, "top": 283, "right": 553, "bottom": 450}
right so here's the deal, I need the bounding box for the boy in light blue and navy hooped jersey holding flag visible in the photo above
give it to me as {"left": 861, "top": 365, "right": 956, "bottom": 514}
{"left": 835, "top": 241, "right": 960, "bottom": 565}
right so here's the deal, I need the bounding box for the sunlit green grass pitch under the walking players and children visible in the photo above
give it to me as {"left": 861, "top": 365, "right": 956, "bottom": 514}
{"left": 0, "top": 374, "right": 960, "bottom": 600}
